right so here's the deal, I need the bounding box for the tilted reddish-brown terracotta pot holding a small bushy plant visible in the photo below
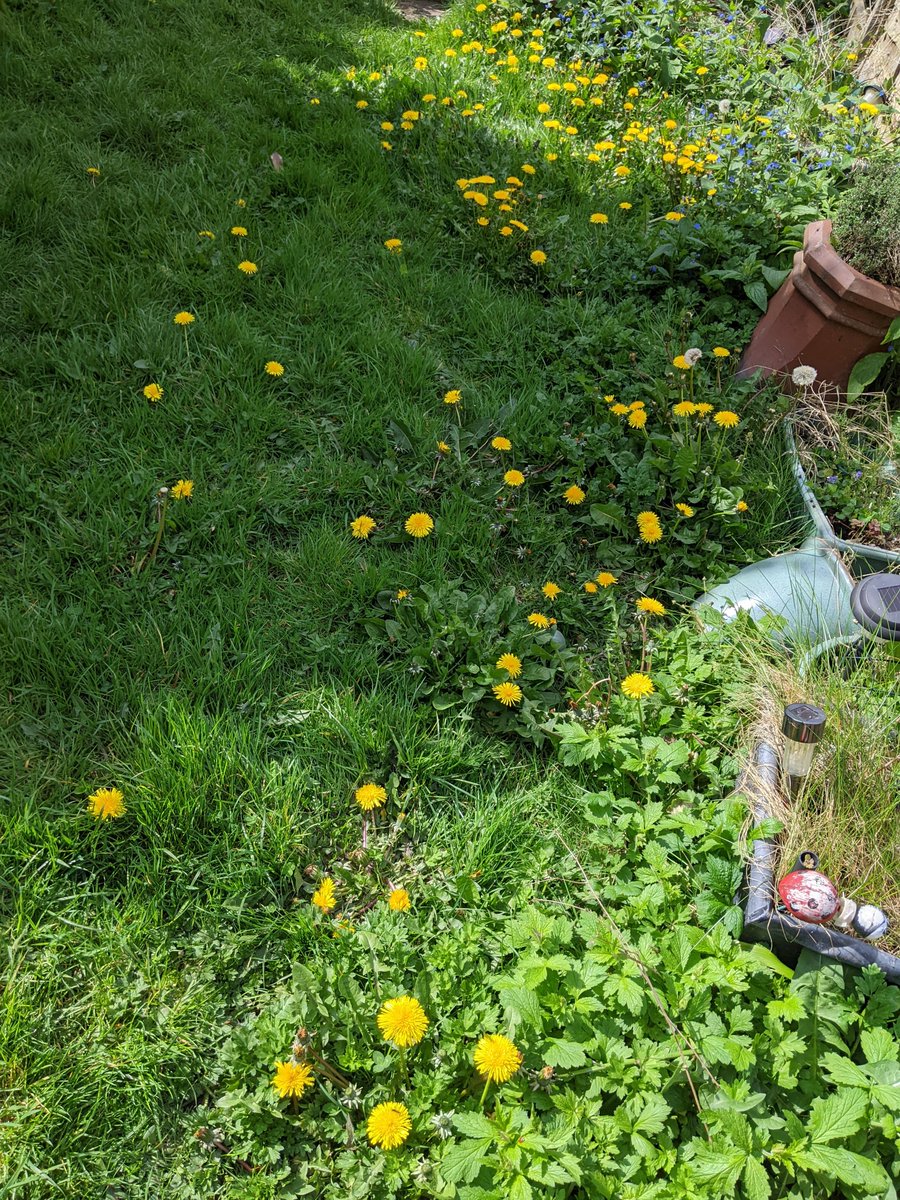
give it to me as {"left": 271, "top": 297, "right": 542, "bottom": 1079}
{"left": 738, "top": 221, "right": 900, "bottom": 391}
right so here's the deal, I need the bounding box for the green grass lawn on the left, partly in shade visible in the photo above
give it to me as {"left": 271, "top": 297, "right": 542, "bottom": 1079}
{"left": 0, "top": 0, "right": 873, "bottom": 1200}
